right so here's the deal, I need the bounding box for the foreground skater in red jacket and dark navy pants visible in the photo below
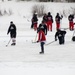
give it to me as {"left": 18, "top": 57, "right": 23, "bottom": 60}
{"left": 37, "top": 28, "right": 46, "bottom": 54}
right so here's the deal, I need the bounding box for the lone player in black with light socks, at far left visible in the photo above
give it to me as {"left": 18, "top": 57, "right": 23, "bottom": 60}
{"left": 7, "top": 21, "right": 16, "bottom": 45}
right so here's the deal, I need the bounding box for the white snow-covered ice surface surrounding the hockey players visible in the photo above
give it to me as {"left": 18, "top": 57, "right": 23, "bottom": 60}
{"left": 0, "top": 1, "right": 75, "bottom": 75}
